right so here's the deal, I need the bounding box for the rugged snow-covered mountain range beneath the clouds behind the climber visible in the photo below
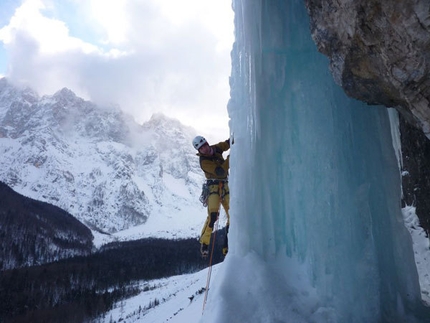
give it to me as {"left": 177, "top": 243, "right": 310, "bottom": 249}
{"left": 0, "top": 78, "right": 205, "bottom": 239}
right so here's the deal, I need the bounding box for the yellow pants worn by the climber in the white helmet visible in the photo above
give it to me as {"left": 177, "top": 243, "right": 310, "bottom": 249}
{"left": 200, "top": 182, "right": 230, "bottom": 248}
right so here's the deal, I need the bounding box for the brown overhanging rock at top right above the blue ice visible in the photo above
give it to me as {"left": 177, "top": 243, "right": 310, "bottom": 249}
{"left": 306, "top": 0, "right": 430, "bottom": 138}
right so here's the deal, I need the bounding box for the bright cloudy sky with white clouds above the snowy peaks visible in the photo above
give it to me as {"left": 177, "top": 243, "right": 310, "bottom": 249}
{"left": 0, "top": 0, "right": 234, "bottom": 141}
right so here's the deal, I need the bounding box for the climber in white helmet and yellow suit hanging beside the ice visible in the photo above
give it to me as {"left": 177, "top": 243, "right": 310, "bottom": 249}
{"left": 193, "top": 136, "right": 230, "bottom": 257}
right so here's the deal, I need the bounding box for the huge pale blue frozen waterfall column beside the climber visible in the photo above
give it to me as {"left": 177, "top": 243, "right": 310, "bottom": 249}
{"left": 201, "top": 0, "right": 430, "bottom": 323}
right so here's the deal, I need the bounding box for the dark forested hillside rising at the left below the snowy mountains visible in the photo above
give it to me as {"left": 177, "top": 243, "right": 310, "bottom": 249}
{"left": 0, "top": 181, "right": 94, "bottom": 271}
